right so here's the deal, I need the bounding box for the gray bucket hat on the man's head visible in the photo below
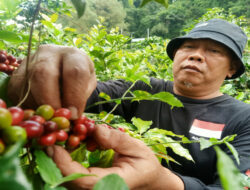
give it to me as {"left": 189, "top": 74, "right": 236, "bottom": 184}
{"left": 166, "top": 19, "right": 247, "bottom": 79}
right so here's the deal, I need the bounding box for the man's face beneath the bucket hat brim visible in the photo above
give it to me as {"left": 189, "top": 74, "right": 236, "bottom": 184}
{"left": 173, "top": 39, "right": 234, "bottom": 90}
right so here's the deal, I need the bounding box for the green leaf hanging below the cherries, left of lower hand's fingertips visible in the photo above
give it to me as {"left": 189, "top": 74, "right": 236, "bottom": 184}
{"left": 34, "top": 150, "right": 63, "bottom": 185}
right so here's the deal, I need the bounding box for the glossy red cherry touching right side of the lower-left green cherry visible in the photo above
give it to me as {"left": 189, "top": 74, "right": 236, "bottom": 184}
{"left": 19, "top": 120, "right": 44, "bottom": 139}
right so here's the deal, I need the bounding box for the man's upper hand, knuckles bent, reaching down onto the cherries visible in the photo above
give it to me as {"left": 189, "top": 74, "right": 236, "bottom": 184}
{"left": 8, "top": 45, "right": 96, "bottom": 119}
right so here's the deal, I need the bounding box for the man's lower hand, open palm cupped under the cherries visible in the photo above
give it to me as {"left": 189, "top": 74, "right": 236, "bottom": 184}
{"left": 47, "top": 125, "right": 184, "bottom": 190}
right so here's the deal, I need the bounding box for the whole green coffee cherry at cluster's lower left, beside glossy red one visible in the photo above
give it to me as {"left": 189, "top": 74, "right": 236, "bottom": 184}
{"left": 3, "top": 126, "right": 27, "bottom": 144}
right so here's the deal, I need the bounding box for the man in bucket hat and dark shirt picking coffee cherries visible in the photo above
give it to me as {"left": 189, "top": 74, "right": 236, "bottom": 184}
{"left": 6, "top": 19, "right": 250, "bottom": 190}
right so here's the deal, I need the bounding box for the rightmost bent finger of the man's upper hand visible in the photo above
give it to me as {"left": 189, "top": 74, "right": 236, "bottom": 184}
{"left": 62, "top": 50, "right": 96, "bottom": 119}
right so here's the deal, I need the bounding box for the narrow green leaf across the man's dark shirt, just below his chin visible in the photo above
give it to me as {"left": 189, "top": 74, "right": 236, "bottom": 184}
{"left": 133, "top": 90, "right": 183, "bottom": 107}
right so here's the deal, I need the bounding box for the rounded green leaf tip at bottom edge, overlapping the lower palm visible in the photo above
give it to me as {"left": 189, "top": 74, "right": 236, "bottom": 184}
{"left": 93, "top": 174, "right": 129, "bottom": 190}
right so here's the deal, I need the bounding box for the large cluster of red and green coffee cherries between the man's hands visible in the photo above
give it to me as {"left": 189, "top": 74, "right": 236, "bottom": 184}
{"left": 0, "top": 99, "right": 107, "bottom": 154}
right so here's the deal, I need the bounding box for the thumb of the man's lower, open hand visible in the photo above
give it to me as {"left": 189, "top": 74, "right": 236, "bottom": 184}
{"left": 94, "top": 125, "right": 154, "bottom": 158}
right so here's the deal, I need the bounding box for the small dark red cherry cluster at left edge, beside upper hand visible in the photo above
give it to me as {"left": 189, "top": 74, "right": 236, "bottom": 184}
{"left": 0, "top": 50, "right": 22, "bottom": 75}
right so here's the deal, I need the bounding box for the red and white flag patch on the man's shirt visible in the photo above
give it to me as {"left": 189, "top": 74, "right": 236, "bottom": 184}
{"left": 189, "top": 119, "right": 225, "bottom": 139}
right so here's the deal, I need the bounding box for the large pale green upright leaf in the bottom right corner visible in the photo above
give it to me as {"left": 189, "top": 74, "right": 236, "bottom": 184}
{"left": 214, "top": 146, "right": 243, "bottom": 190}
